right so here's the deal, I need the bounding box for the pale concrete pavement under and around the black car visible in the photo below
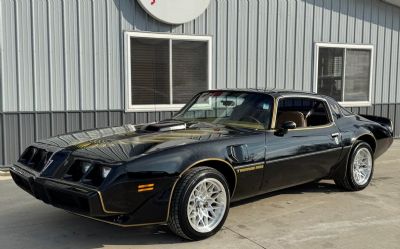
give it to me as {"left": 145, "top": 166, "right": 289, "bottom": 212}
{"left": 0, "top": 141, "right": 400, "bottom": 249}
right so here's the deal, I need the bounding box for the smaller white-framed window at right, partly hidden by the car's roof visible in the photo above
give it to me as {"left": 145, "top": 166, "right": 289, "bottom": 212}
{"left": 315, "top": 43, "right": 373, "bottom": 106}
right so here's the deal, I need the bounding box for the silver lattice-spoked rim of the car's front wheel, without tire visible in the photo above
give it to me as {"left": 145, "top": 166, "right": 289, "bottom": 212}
{"left": 187, "top": 178, "right": 227, "bottom": 233}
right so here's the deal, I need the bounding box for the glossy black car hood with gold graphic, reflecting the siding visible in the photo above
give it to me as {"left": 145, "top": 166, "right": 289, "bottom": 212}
{"left": 36, "top": 121, "right": 239, "bottom": 162}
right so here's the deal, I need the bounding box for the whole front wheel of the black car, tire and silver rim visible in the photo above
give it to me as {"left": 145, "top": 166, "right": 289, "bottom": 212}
{"left": 168, "top": 167, "right": 230, "bottom": 240}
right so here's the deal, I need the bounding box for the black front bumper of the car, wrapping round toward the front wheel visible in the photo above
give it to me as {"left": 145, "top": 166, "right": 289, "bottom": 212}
{"left": 10, "top": 164, "right": 177, "bottom": 227}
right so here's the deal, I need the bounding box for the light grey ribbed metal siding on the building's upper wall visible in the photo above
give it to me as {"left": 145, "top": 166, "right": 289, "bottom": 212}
{"left": 0, "top": 0, "right": 400, "bottom": 112}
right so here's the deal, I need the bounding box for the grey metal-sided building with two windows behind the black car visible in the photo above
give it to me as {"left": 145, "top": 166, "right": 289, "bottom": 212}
{"left": 0, "top": 0, "right": 400, "bottom": 165}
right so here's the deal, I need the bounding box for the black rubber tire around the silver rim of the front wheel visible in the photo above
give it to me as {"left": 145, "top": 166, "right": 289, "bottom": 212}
{"left": 168, "top": 166, "right": 230, "bottom": 240}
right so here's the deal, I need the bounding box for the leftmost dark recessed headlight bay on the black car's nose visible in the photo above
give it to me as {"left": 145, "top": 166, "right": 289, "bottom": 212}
{"left": 18, "top": 146, "right": 53, "bottom": 171}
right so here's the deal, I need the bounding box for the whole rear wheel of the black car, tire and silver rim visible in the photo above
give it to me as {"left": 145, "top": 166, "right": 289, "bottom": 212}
{"left": 334, "top": 142, "right": 374, "bottom": 191}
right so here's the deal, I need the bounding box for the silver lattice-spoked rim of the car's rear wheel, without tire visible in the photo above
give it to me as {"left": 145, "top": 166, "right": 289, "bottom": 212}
{"left": 352, "top": 148, "right": 372, "bottom": 186}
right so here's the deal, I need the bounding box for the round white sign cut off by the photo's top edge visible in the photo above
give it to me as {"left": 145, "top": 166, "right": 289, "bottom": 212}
{"left": 137, "top": 0, "right": 210, "bottom": 24}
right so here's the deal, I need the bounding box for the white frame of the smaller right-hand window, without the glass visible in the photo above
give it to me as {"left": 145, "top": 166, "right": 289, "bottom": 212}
{"left": 314, "top": 42, "right": 374, "bottom": 107}
